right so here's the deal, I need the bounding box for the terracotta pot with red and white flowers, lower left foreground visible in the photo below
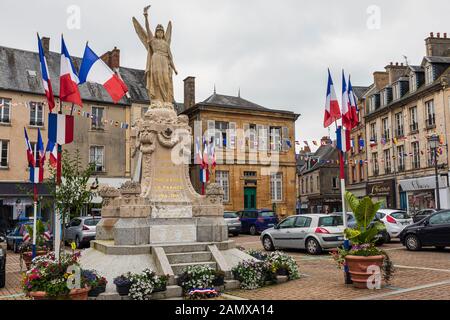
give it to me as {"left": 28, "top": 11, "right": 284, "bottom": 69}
{"left": 22, "top": 253, "right": 91, "bottom": 300}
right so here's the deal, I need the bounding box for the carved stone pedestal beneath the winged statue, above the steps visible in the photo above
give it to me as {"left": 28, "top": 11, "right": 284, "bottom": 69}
{"left": 97, "top": 104, "right": 228, "bottom": 246}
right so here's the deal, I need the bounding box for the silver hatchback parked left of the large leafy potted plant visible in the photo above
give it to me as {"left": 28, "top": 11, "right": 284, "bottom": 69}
{"left": 260, "top": 214, "right": 344, "bottom": 255}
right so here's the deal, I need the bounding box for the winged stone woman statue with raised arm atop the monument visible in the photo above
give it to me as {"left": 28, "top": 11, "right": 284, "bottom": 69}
{"left": 133, "top": 6, "right": 178, "bottom": 105}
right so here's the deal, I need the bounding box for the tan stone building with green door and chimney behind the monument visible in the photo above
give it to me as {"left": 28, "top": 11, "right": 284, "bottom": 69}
{"left": 182, "top": 77, "right": 299, "bottom": 216}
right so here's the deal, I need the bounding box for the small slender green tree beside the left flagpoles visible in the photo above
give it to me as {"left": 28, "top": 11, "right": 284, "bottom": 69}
{"left": 46, "top": 149, "right": 95, "bottom": 251}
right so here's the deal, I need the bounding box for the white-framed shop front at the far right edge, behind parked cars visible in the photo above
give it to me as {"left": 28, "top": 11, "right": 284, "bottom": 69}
{"left": 398, "top": 176, "right": 449, "bottom": 213}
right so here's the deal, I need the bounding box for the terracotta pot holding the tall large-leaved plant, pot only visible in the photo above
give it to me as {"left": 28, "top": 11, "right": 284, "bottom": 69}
{"left": 345, "top": 255, "right": 384, "bottom": 289}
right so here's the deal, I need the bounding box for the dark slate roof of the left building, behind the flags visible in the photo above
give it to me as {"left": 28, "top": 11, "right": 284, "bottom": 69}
{"left": 0, "top": 46, "right": 149, "bottom": 105}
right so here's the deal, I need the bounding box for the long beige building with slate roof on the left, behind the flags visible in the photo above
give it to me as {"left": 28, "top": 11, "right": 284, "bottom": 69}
{"left": 0, "top": 38, "right": 149, "bottom": 229}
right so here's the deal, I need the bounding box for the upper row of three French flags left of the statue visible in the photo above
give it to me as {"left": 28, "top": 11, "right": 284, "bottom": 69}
{"left": 38, "top": 34, "right": 128, "bottom": 112}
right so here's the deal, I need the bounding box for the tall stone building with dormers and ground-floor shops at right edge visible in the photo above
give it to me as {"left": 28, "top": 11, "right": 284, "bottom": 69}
{"left": 365, "top": 33, "right": 450, "bottom": 211}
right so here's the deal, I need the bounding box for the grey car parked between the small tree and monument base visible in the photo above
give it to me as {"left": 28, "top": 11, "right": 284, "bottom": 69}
{"left": 64, "top": 216, "right": 101, "bottom": 248}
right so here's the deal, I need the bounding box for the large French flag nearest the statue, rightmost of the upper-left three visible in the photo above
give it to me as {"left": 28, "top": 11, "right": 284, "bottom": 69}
{"left": 80, "top": 44, "right": 128, "bottom": 103}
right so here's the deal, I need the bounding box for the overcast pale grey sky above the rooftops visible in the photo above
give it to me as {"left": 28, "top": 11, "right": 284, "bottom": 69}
{"left": 0, "top": 0, "right": 450, "bottom": 151}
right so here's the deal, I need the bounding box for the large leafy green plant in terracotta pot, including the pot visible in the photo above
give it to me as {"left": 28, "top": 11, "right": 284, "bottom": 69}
{"left": 333, "top": 192, "right": 394, "bottom": 288}
